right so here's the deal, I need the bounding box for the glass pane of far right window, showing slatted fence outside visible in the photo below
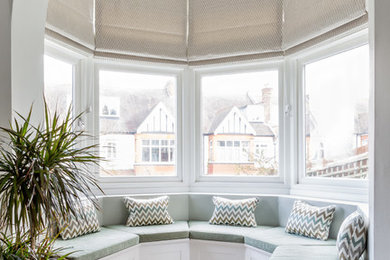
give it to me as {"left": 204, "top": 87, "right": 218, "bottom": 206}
{"left": 305, "top": 46, "right": 369, "bottom": 178}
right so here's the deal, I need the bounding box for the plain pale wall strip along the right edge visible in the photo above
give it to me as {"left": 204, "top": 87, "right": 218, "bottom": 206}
{"left": 369, "top": 0, "right": 390, "bottom": 260}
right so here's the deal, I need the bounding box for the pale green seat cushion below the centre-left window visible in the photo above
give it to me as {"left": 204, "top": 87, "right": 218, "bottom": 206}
{"left": 107, "top": 221, "right": 189, "bottom": 243}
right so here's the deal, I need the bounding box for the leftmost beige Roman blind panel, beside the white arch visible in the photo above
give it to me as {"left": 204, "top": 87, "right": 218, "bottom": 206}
{"left": 46, "top": 0, "right": 95, "bottom": 49}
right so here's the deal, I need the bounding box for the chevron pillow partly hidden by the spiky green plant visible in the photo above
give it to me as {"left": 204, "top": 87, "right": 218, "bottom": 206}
{"left": 58, "top": 201, "right": 100, "bottom": 240}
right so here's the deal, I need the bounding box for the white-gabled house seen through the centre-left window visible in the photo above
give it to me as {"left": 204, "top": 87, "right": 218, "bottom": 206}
{"left": 100, "top": 83, "right": 176, "bottom": 176}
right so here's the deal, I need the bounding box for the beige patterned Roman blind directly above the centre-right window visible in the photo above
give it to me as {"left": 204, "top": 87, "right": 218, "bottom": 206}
{"left": 188, "top": 0, "right": 283, "bottom": 61}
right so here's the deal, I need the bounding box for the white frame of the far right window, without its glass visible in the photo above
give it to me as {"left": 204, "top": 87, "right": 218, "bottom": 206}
{"left": 293, "top": 30, "right": 368, "bottom": 190}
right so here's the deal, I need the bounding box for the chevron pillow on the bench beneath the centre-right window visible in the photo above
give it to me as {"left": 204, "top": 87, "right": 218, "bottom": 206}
{"left": 209, "top": 197, "right": 259, "bottom": 227}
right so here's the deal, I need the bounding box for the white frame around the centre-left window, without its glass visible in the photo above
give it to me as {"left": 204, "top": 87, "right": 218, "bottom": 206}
{"left": 91, "top": 58, "right": 185, "bottom": 184}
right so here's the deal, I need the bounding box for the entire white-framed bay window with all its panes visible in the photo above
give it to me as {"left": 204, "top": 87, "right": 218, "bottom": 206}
{"left": 44, "top": 27, "right": 370, "bottom": 199}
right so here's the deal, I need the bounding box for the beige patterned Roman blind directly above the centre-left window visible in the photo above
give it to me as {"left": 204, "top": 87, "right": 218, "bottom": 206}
{"left": 96, "top": 0, "right": 187, "bottom": 60}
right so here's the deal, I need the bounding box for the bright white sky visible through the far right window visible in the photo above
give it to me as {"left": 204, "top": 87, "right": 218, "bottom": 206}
{"left": 305, "top": 45, "right": 369, "bottom": 159}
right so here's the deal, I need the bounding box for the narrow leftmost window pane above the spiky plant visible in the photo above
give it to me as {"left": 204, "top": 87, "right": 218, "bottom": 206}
{"left": 44, "top": 55, "right": 73, "bottom": 119}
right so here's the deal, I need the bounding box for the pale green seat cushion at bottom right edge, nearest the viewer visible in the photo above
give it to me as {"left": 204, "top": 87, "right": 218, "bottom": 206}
{"left": 270, "top": 245, "right": 337, "bottom": 260}
